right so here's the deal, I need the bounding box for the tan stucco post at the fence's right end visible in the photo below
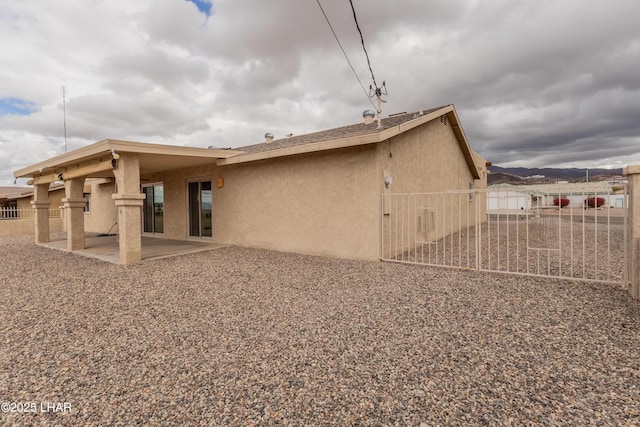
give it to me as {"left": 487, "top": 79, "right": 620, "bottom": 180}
{"left": 623, "top": 165, "right": 640, "bottom": 299}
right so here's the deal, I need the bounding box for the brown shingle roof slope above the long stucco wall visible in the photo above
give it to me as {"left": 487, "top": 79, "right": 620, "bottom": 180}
{"left": 234, "top": 106, "right": 445, "bottom": 154}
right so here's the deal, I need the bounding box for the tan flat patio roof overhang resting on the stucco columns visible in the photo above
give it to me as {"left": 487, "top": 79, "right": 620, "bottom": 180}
{"left": 13, "top": 139, "right": 242, "bottom": 184}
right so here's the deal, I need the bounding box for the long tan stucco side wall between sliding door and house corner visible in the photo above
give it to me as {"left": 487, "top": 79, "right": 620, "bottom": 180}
{"left": 214, "top": 145, "right": 380, "bottom": 260}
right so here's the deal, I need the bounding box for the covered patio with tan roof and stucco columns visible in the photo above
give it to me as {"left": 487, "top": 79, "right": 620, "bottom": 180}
{"left": 14, "top": 139, "right": 241, "bottom": 264}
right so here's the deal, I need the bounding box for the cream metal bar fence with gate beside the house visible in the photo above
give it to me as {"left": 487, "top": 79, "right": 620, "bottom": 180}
{"left": 381, "top": 184, "right": 628, "bottom": 283}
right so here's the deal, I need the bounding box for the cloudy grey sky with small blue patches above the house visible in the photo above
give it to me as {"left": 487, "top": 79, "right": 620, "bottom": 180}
{"left": 0, "top": 0, "right": 640, "bottom": 185}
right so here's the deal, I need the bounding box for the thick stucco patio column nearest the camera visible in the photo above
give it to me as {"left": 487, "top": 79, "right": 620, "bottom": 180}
{"left": 111, "top": 153, "right": 145, "bottom": 264}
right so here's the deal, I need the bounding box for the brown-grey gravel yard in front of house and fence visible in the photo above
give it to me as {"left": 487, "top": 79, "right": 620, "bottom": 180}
{"left": 0, "top": 237, "right": 640, "bottom": 426}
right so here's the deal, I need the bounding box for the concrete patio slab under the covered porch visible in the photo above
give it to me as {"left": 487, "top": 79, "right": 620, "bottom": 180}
{"left": 41, "top": 236, "right": 228, "bottom": 264}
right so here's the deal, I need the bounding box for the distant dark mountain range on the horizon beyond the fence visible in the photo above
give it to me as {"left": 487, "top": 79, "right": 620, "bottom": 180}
{"left": 488, "top": 166, "right": 622, "bottom": 185}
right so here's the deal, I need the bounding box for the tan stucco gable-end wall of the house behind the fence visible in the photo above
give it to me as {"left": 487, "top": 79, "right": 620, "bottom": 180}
{"left": 377, "top": 120, "right": 486, "bottom": 258}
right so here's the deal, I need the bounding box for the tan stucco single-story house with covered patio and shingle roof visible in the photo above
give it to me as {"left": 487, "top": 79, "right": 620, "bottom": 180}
{"left": 14, "top": 105, "right": 487, "bottom": 264}
